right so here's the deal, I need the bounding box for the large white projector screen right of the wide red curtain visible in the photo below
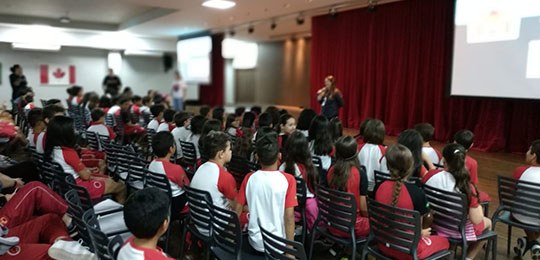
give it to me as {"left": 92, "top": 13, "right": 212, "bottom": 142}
{"left": 450, "top": 0, "right": 540, "bottom": 99}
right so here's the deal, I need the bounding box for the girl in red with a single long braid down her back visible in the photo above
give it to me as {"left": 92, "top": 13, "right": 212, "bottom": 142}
{"left": 375, "top": 144, "right": 449, "bottom": 259}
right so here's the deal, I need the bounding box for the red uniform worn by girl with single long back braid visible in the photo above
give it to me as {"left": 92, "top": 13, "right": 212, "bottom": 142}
{"left": 375, "top": 181, "right": 449, "bottom": 259}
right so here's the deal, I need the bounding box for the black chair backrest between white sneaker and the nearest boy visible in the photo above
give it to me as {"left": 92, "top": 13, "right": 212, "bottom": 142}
{"left": 83, "top": 210, "right": 114, "bottom": 260}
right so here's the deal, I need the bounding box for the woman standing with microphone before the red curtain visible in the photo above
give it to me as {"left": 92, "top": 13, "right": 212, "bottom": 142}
{"left": 317, "top": 75, "right": 343, "bottom": 119}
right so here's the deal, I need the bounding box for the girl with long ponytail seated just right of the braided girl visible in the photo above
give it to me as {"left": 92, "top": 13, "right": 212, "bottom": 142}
{"left": 422, "top": 143, "right": 491, "bottom": 259}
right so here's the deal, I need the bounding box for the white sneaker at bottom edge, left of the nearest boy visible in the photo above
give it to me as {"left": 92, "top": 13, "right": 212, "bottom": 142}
{"left": 48, "top": 240, "right": 98, "bottom": 260}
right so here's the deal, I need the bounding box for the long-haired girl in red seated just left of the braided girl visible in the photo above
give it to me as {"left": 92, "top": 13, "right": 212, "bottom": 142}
{"left": 326, "top": 136, "right": 369, "bottom": 237}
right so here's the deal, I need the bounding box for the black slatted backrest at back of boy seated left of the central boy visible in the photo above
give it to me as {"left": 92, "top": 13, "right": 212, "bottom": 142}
{"left": 184, "top": 186, "right": 213, "bottom": 236}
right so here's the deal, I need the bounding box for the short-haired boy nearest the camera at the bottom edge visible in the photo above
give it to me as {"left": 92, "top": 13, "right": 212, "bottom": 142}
{"left": 117, "top": 188, "right": 174, "bottom": 260}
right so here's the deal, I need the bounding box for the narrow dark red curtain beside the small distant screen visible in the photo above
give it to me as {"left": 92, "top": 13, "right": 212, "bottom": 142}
{"left": 199, "top": 33, "right": 225, "bottom": 106}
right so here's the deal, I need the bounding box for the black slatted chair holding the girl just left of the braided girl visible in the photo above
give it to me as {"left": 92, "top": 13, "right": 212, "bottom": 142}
{"left": 309, "top": 185, "right": 366, "bottom": 259}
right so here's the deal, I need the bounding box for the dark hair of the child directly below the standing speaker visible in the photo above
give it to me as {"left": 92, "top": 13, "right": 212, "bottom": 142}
{"left": 308, "top": 115, "right": 333, "bottom": 155}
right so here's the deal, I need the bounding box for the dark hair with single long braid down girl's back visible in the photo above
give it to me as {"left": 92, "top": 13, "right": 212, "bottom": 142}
{"left": 385, "top": 144, "right": 414, "bottom": 207}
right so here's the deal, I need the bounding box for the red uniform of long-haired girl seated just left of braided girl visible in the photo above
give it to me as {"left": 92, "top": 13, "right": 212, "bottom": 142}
{"left": 326, "top": 167, "right": 369, "bottom": 237}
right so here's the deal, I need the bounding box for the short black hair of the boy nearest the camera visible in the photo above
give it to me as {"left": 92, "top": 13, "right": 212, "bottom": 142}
{"left": 124, "top": 188, "right": 170, "bottom": 239}
